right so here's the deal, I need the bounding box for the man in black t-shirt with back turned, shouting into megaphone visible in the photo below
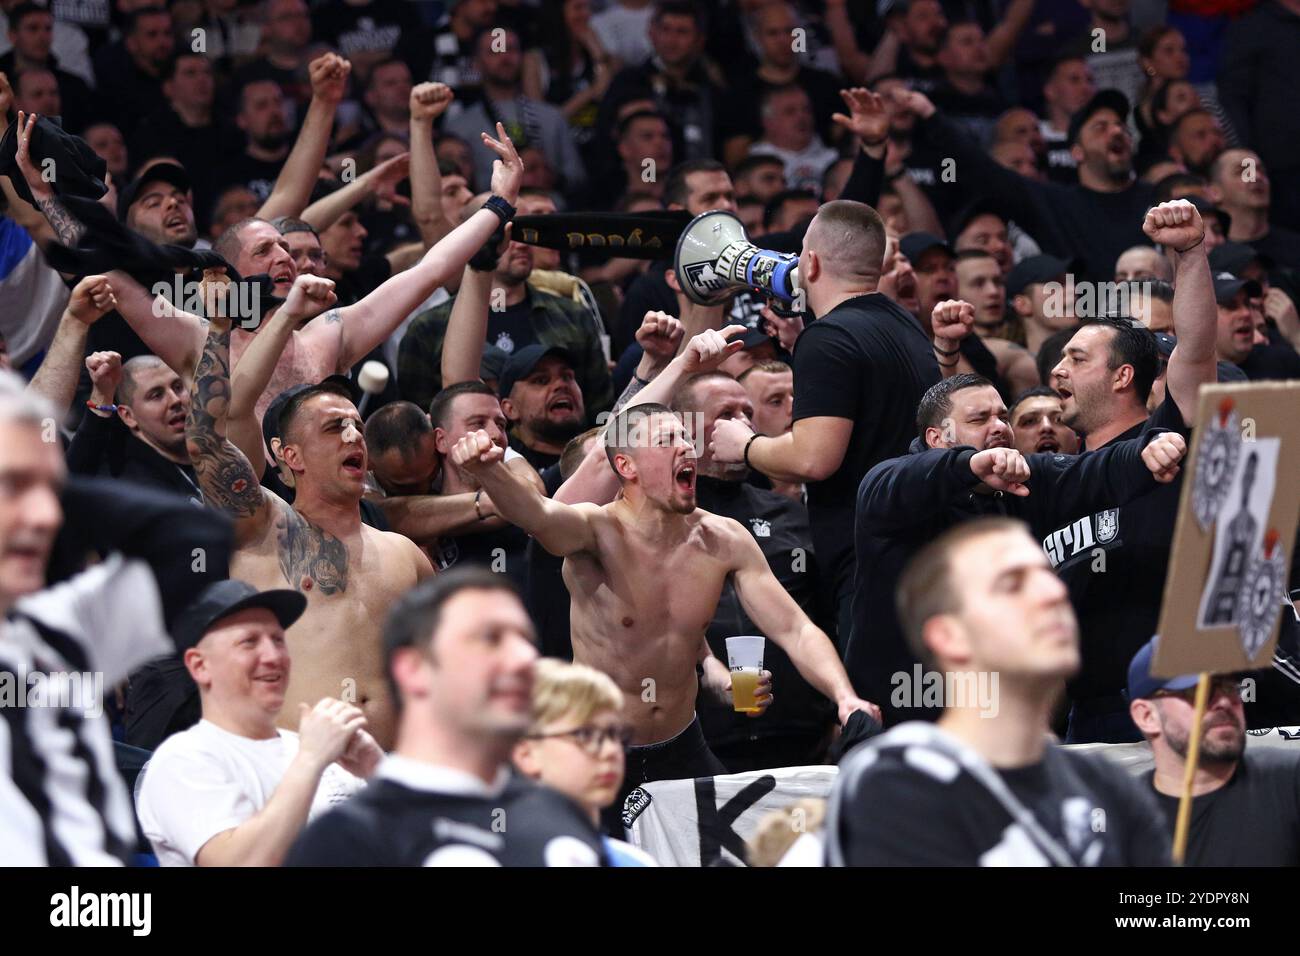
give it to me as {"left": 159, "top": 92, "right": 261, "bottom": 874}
{"left": 712, "top": 199, "right": 952, "bottom": 648}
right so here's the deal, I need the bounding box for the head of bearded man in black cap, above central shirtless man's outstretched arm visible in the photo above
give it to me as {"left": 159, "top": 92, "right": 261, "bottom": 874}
{"left": 498, "top": 345, "right": 586, "bottom": 471}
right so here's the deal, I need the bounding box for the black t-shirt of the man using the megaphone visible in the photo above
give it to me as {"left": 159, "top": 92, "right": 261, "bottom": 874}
{"left": 794, "top": 293, "right": 940, "bottom": 590}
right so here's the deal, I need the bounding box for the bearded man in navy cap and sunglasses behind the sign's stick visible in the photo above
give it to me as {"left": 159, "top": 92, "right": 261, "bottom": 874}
{"left": 1128, "top": 637, "right": 1300, "bottom": 866}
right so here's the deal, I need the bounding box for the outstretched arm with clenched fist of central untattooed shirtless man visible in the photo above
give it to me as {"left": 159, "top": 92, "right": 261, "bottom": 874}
{"left": 451, "top": 429, "right": 599, "bottom": 558}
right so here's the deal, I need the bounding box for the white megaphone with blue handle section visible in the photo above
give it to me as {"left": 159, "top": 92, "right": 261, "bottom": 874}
{"left": 672, "top": 209, "right": 800, "bottom": 306}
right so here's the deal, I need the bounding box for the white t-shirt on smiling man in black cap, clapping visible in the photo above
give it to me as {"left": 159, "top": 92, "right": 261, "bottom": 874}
{"left": 135, "top": 721, "right": 364, "bottom": 866}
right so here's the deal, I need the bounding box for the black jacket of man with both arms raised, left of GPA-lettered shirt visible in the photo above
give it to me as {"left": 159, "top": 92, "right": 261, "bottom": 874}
{"left": 845, "top": 429, "right": 1160, "bottom": 723}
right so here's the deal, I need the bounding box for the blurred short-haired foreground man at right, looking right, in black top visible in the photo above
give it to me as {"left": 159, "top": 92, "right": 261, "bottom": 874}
{"left": 824, "top": 518, "right": 1169, "bottom": 866}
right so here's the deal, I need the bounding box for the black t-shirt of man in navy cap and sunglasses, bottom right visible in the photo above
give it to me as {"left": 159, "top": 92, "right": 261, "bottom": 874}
{"left": 1143, "top": 747, "right": 1300, "bottom": 866}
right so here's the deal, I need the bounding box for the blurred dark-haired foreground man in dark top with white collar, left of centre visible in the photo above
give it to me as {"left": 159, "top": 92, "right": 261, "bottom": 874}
{"left": 286, "top": 568, "right": 603, "bottom": 866}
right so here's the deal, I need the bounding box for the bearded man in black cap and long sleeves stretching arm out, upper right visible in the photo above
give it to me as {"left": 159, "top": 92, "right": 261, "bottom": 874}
{"left": 892, "top": 90, "right": 1156, "bottom": 281}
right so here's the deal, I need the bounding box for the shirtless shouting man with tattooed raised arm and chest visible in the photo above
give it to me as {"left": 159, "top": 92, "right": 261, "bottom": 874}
{"left": 185, "top": 278, "right": 433, "bottom": 749}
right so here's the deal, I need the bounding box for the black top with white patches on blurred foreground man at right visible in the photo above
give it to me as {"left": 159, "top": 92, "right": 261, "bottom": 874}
{"left": 828, "top": 723, "right": 1169, "bottom": 866}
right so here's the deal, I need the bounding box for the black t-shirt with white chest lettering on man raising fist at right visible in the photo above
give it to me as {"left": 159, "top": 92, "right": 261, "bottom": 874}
{"left": 1043, "top": 395, "right": 1188, "bottom": 700}
